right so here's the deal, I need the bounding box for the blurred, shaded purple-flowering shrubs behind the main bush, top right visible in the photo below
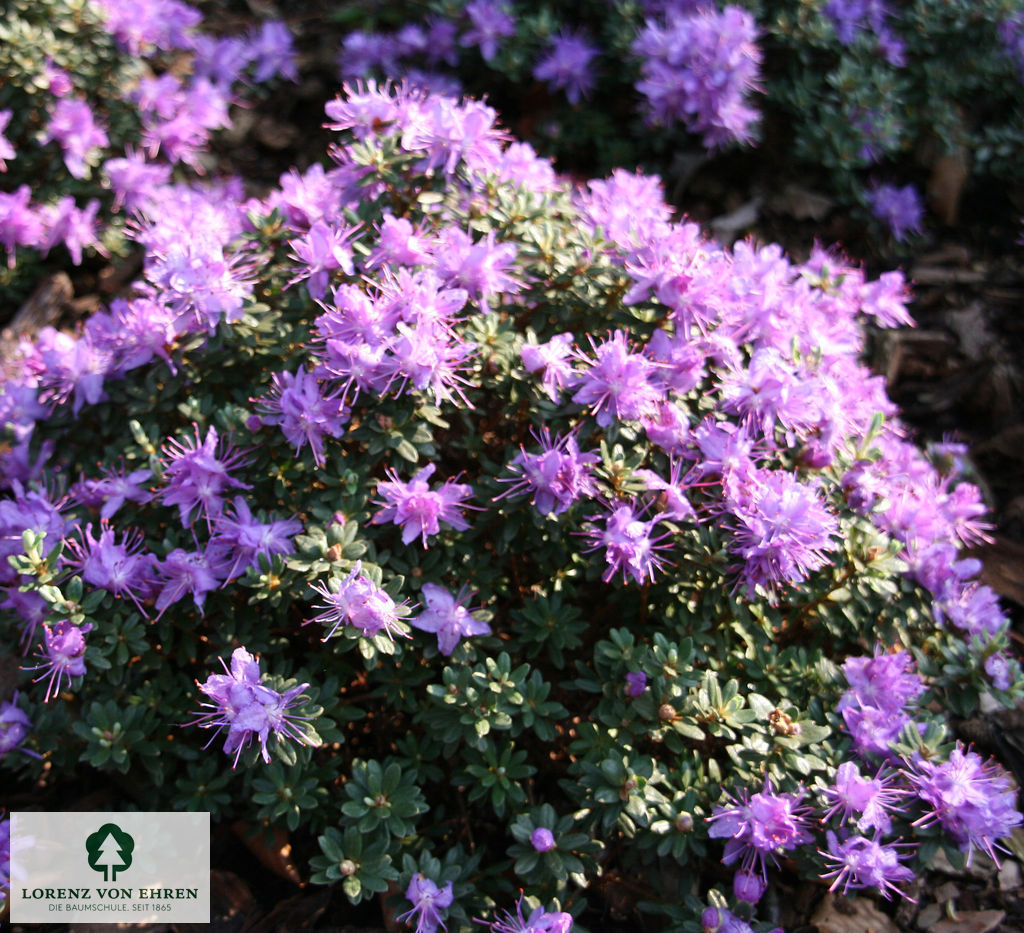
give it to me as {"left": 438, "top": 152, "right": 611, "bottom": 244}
{"left": 329, "top": 0, "right": 1024, "bottom": 241}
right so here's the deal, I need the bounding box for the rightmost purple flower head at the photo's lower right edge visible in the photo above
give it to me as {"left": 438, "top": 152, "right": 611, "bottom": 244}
{"left": 903, "top": 744, "right": 1024, "bottom": 864}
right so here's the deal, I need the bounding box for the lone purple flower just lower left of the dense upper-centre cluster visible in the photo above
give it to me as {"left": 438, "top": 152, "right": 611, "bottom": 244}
{"left": 251, "top": 370, "right": 348, "bottom": 467}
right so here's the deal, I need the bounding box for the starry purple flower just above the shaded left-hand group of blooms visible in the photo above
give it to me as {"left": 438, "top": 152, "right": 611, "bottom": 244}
{"left": 157, "top": 424, "right": 258, "bottom": 527}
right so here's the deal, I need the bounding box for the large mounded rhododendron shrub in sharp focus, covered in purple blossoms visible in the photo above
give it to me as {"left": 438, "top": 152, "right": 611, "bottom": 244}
{"left": 0, "top": 83, "right": 1021, "bottom": 931}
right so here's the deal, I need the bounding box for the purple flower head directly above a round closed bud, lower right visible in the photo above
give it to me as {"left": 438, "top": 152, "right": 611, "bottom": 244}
{"left": 708, "top": 778, "right": 812, "bottom": 877}
